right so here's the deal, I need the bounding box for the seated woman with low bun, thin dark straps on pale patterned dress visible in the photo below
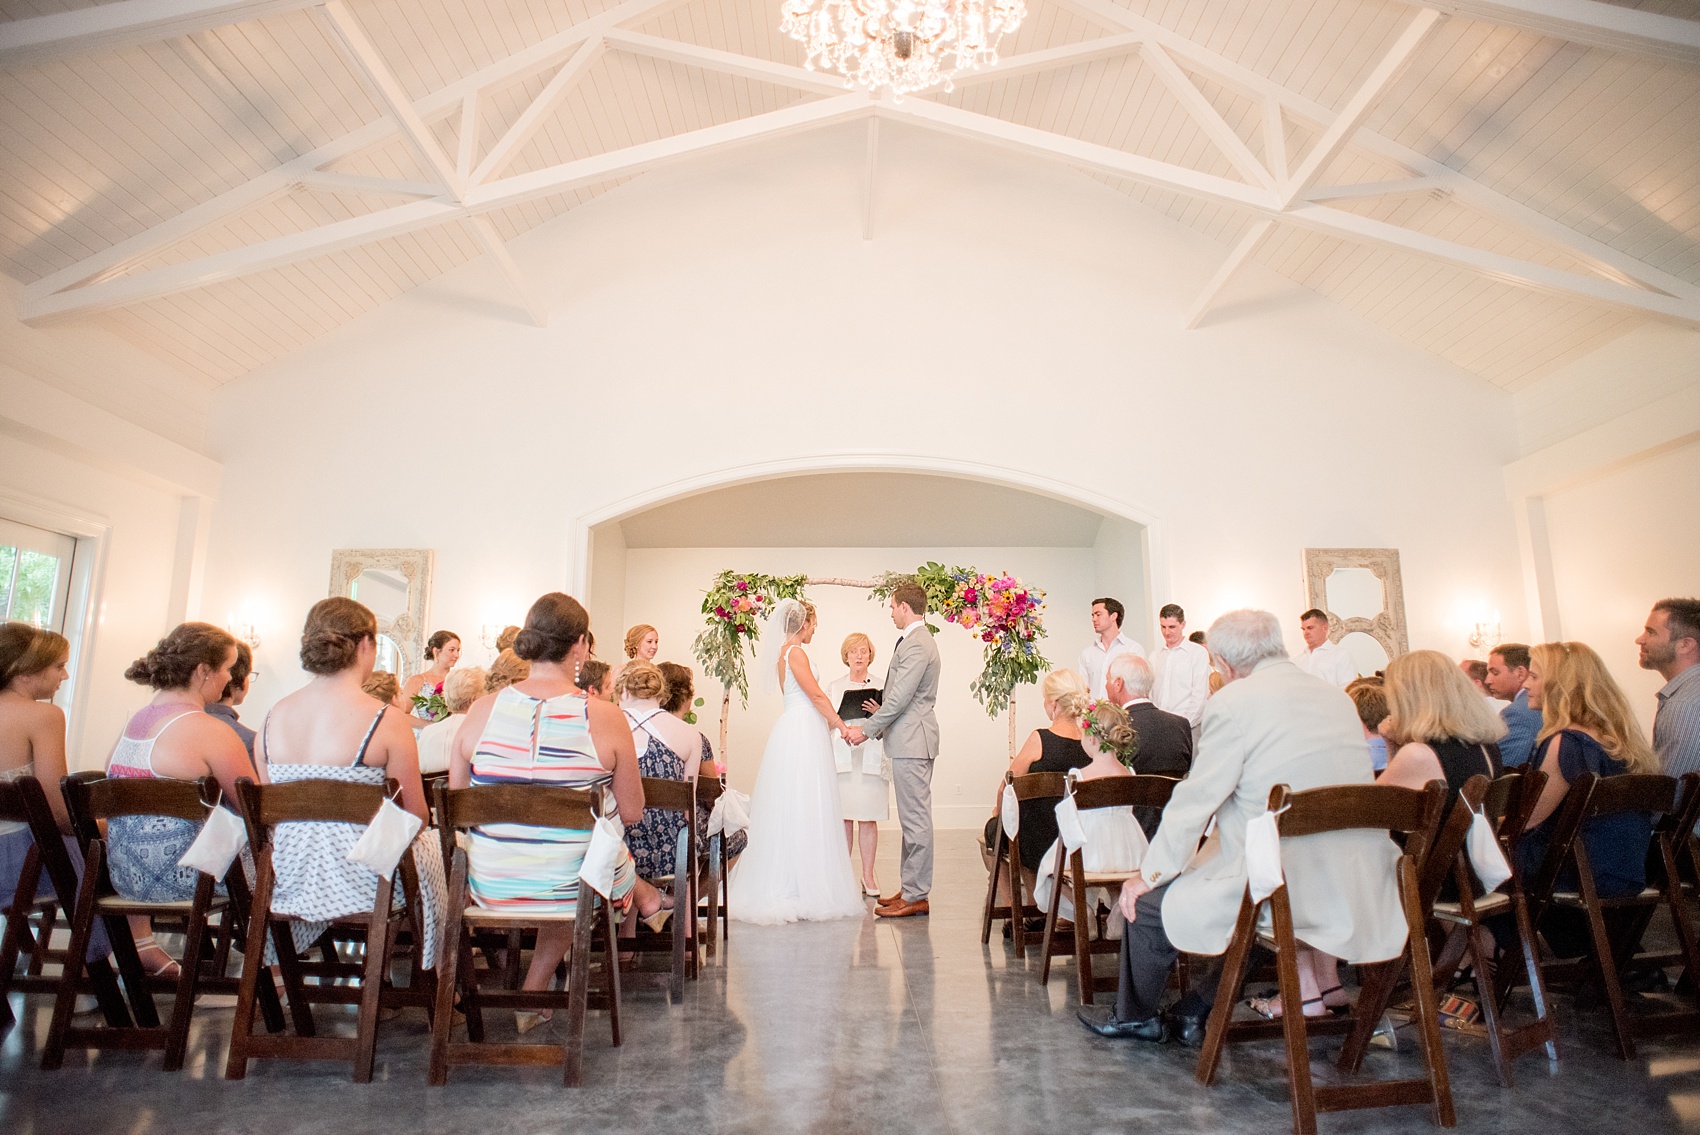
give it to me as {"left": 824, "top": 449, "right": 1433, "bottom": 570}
{"left": 258, "top": 596, "right": 449, "bottom": 968}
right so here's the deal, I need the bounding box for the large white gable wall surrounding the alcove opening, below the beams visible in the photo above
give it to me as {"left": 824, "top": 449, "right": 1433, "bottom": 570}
{"left": 206, "top": 127, "right": 1525, "bottom": 727}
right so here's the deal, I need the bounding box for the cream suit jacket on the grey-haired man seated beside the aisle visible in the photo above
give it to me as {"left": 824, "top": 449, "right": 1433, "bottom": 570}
{"left": 1141, "top": 659, "right": 1406, "bottom": 963}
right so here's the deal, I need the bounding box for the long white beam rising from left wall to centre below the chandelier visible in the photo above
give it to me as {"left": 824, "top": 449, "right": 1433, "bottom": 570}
{"left": 19, "top": 95, "right": 872, "bottom": 323}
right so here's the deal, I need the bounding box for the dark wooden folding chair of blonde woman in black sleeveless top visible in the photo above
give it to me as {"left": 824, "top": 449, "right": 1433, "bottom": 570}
{"left": 1433, "top": 768, "right": 1559, "bottom": 1087}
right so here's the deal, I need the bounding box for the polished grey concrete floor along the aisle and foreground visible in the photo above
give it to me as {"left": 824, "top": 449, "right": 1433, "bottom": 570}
{"left": 0, "top": 831, "right": 1700, "bottom": 1135}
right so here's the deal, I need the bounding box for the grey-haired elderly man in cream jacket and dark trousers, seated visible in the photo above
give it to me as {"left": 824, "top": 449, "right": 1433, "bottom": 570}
{"left": 1080, "top": 610, "right": 1406, "bottom": 1047}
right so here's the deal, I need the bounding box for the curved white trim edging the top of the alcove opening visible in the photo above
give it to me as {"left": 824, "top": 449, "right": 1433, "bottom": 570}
{"left": 568, "top": 452, "right": 1170, "bottom": 611}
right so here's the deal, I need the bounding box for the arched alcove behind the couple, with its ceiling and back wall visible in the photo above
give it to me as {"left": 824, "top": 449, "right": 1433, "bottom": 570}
{"left": 576, "top": 459, "right": 1154, "bottom": 827}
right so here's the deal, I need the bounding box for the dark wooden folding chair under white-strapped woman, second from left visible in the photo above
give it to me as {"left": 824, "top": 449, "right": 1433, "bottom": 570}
{"left": 41, "top": 776, "right": 282, "bottom": 1072}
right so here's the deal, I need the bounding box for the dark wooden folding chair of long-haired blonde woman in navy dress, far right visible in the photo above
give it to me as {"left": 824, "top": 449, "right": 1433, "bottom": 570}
{"left": 1530, "top": 773, "right": 1700, "bottom": 1060}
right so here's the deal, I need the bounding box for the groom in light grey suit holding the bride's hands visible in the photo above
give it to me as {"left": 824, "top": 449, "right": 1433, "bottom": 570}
{"left": 845, "top": 583, "right": 938, "bottom": 918}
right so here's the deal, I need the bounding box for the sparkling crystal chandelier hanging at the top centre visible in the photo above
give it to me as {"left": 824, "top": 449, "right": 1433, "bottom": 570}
{"left": 779, "top": 0, "right": 1027, "bottom": 97}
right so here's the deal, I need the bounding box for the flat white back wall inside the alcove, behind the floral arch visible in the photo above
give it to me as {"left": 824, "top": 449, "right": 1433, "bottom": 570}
{"left": 622, "top": 547, "right": 1093, "bottom": 827}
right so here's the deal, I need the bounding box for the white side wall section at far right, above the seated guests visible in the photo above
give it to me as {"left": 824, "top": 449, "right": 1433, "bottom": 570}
{"left": 1545, "top": 440, "right": 1700, "bottom": 731}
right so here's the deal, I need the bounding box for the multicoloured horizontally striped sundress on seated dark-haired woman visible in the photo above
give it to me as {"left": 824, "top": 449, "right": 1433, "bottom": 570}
{"left": 466, "top": 686, "right": 638, "bottom": 914}
